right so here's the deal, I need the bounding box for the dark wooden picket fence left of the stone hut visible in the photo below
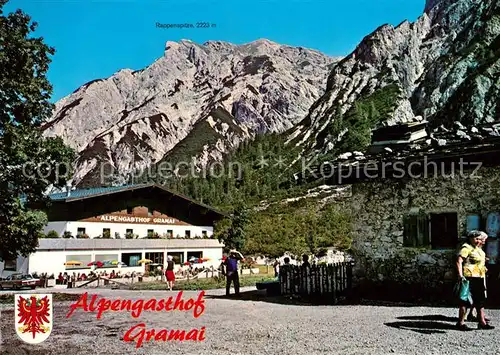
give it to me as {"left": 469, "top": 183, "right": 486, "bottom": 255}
{"left": 279, "top": 262, "right": 353, "bottom": 303}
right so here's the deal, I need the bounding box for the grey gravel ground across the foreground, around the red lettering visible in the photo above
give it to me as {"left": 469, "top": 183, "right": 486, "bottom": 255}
{"left": 0, "top": 287, "right": 500, "bottom": 355}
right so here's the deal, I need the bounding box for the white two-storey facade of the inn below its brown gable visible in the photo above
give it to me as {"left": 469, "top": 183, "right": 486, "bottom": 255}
{"left": 0, "top": 221, "right": 223, "bottom": 277}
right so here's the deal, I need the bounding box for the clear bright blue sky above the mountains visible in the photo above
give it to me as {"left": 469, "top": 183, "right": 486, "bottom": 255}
{"left": 4, "top": 0, "right": 425, "bottom": 101}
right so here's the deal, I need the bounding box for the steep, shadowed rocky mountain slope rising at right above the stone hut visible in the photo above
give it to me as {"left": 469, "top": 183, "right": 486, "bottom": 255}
{"left": 288, "top": 0, "right": 500, "bottom": 160}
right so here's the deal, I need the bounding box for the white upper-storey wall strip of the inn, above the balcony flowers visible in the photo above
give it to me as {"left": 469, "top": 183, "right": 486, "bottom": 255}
{"left": 44, "top": 221, "right": 213, "bottom": 238}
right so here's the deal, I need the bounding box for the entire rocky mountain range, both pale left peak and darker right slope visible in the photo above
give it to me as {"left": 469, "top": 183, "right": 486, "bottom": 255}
{"left": 45, "top": 0, "right": 500, "bottom": 189}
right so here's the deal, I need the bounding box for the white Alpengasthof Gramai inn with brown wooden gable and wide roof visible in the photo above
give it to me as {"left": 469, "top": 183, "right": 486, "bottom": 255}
{"left": 0, "top": 184, "right": 224, "bottom": 277}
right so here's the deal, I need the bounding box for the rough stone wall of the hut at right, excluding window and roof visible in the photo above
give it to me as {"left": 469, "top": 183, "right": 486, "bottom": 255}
{"left": 350, "top": 167, "right": 500, "bottom": 286}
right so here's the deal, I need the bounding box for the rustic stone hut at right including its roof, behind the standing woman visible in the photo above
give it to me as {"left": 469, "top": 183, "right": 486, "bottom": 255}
{"left": 309, "top": 135, "right": 500, "bottom": 294}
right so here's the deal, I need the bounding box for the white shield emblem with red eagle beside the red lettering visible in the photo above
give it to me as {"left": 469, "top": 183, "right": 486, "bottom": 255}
{"left": 14, "top": 294, "right": 52, "bottom": 344}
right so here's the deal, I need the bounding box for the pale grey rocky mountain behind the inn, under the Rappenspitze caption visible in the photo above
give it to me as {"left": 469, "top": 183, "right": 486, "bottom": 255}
{"left": 44, "top": 39, "right": 337, "bottom": 186}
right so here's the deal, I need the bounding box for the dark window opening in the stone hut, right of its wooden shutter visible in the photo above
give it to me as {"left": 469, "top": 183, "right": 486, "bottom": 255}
{"left": 429, "top": 212, "right": 458, "bottom": 249}
